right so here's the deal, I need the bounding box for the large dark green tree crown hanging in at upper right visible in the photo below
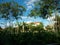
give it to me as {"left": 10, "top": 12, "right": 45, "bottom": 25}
{"left": 30, "top": 0, "right": 60, "bottom": 18}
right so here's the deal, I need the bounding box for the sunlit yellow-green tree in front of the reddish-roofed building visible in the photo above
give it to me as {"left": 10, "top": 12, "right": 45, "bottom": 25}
{"left": 29, "top": 22, "right": 44, "bottom": 32}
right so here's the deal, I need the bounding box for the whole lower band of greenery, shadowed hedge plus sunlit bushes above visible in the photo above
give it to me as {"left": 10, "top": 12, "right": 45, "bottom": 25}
{"left": 0, "top": 23, "right": 60, "bottom": 45}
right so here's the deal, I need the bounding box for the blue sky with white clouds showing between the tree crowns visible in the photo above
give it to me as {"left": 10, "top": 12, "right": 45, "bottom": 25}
{"left": 0, "top": 0, "right": 60, "bottom": 26}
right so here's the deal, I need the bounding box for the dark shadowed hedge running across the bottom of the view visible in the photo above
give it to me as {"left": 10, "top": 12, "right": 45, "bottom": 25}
{"left": 0, "top": 30, "right": 60, "bottom": 45}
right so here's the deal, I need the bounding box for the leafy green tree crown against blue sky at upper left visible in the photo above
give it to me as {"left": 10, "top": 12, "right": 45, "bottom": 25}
{"left": 0, "top": 2, "right": 26, "bottom": 19}
